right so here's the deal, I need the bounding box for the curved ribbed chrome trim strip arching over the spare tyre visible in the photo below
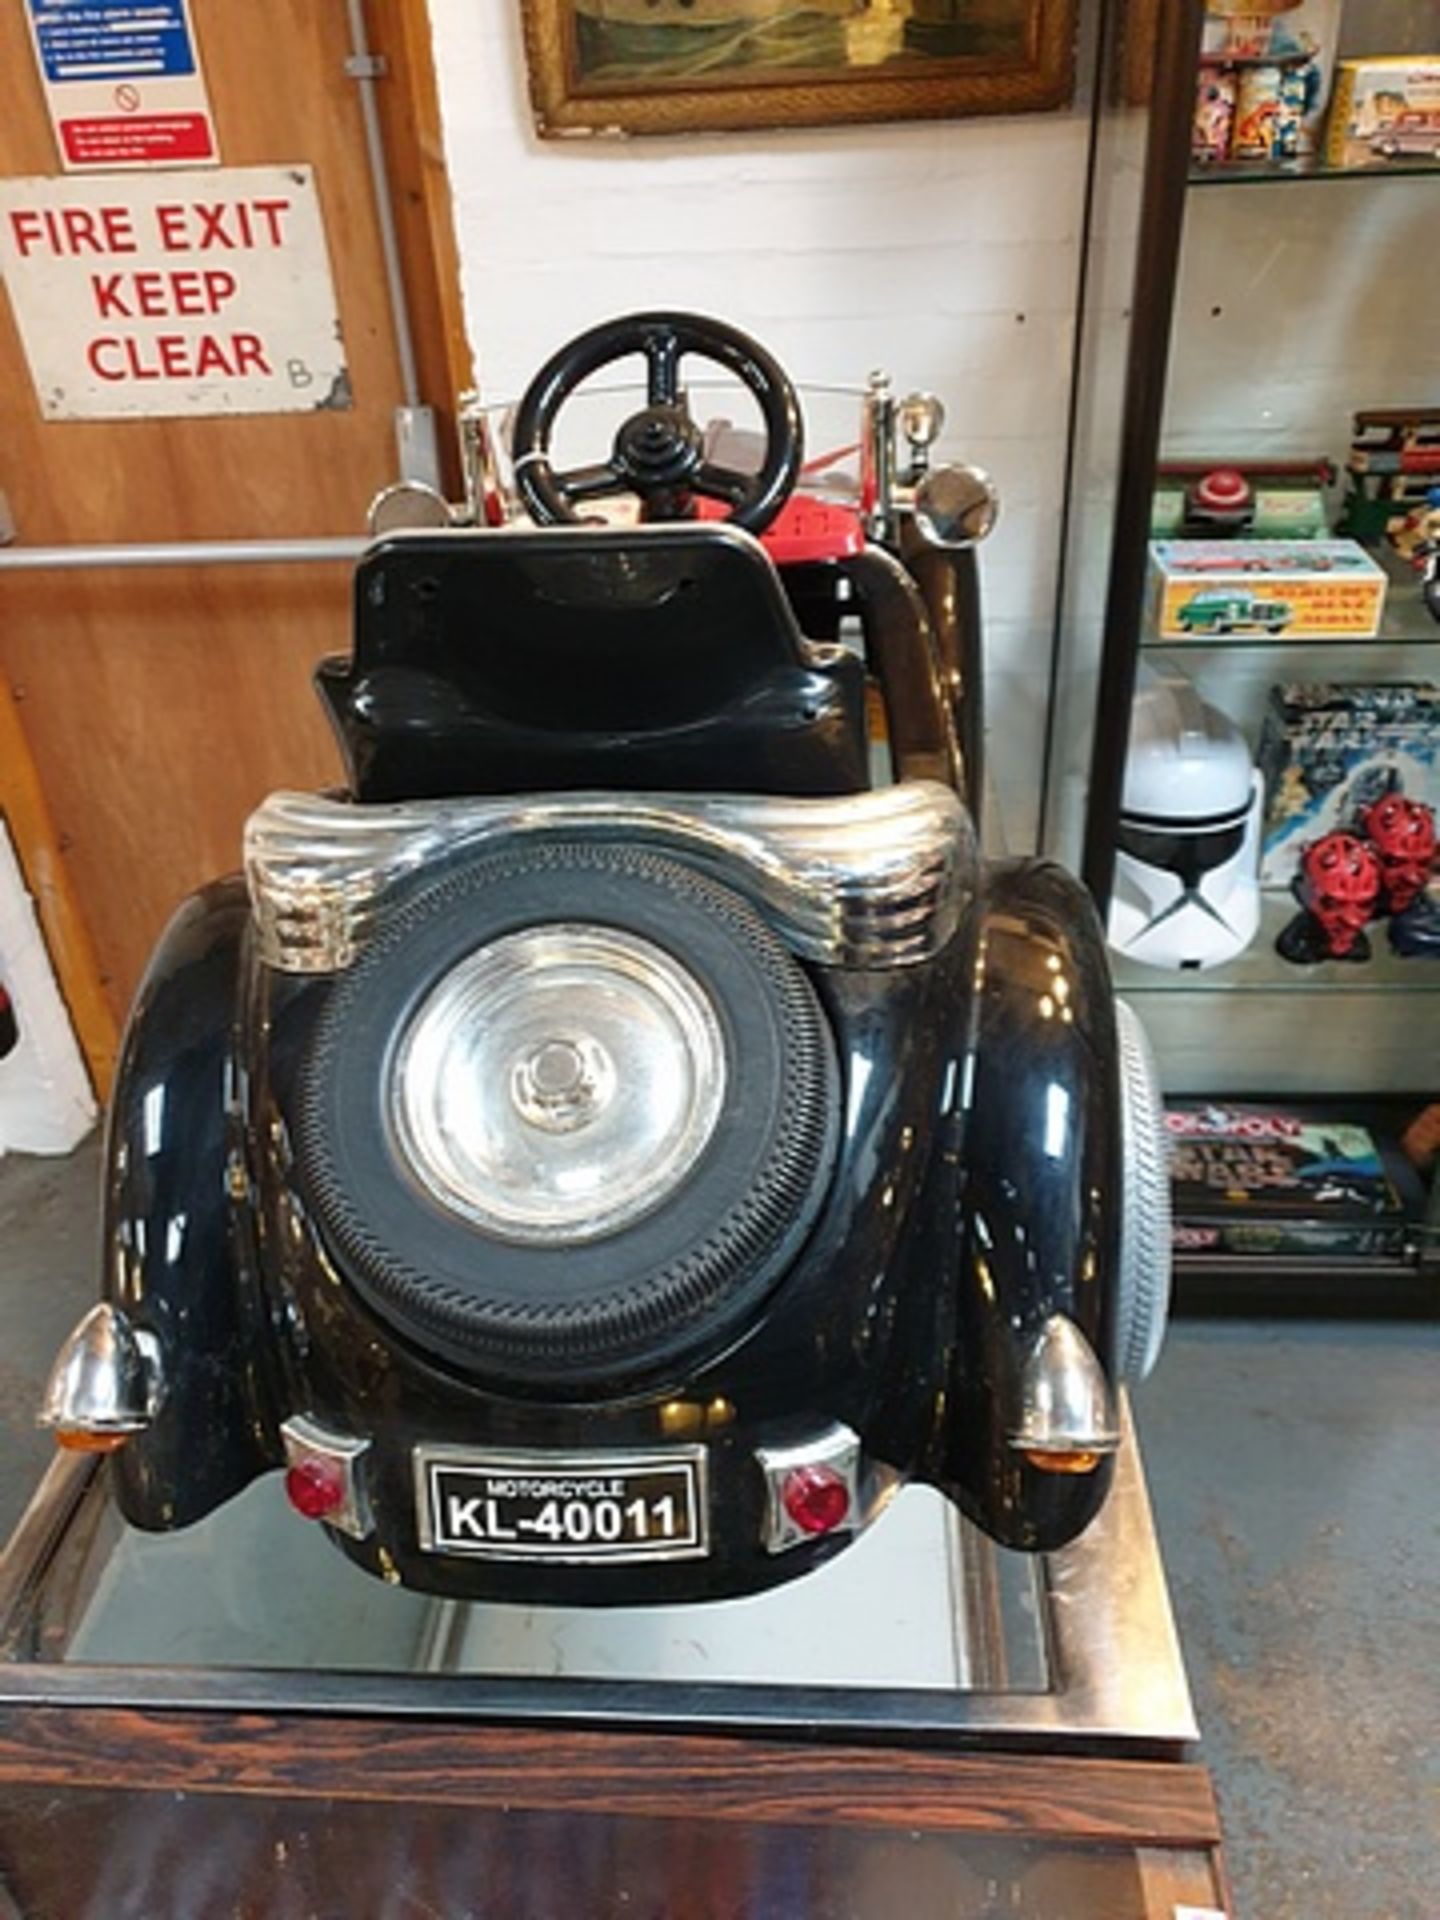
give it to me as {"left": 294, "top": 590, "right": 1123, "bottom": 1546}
{"left": 246, "top": 780, "right": 977, "bottom": 973}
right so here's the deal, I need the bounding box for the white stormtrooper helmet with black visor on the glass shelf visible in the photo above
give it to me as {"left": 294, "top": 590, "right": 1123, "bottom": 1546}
{"left": 1108, "top": 674, "right": 1265, "bottom": 972}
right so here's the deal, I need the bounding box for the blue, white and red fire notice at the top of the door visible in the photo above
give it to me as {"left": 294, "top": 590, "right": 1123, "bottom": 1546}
{"left": 25, "top": 0, "right": 219, "bottom": 173}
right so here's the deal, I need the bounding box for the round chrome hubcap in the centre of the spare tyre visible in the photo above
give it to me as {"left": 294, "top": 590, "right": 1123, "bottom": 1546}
{"left": 386, "top": 924, "right": 726, "bottom": 1244}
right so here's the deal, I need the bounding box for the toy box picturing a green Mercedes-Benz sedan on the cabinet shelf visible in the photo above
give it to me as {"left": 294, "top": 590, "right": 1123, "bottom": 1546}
{"left": 1150, "top": 540, "right": 1386, "bottom": 639}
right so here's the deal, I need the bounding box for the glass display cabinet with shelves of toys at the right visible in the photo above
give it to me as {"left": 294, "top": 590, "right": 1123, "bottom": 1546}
{"left": 1044, "top": 0, "right": 1440, "bottom": 1304}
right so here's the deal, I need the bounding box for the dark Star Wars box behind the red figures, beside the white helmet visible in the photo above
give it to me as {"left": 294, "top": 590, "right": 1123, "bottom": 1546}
{"left": 1256, "top": 680, "right": 1440, "bottom": 887}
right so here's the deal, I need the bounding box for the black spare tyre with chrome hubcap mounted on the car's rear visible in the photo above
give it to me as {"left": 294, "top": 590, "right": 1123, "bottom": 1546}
{"left": 298, "top": 841, "right": 839, "bottom": 1392}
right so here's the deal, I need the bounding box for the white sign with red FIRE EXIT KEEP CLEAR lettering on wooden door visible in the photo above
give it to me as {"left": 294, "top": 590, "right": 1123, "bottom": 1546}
{"left": 0, "top": 167, "right": 349, "bottom": 420}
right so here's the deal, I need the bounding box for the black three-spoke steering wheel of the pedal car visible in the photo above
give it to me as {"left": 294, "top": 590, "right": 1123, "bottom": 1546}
{"left": 513, "top": 313, "right": 804, "bottom": 534}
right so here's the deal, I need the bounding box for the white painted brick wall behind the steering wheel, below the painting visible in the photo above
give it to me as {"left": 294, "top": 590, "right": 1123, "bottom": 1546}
{"left": 420, "top": 0, "right": 1087, "bottom": 849}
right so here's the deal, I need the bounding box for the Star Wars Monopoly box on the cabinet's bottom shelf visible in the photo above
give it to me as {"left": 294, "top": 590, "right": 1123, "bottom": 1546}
{"left": 1165, "top": 1100, "right": 1405, "bottom": 1254}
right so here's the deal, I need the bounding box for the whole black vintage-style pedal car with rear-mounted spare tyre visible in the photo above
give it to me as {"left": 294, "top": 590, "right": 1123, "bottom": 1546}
{"left": 42, "top": 313, "right": 1169, "bottom": 1603}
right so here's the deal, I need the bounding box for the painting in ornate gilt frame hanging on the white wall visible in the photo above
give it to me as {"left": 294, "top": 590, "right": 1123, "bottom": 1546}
{"left": 520, "top": 0, "right": 1077, "bottom": 134}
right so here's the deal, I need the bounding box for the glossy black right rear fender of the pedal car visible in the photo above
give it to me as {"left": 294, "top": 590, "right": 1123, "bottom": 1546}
{"left": 929, "top": 860, "right": 1123, "bottom": 1551}
